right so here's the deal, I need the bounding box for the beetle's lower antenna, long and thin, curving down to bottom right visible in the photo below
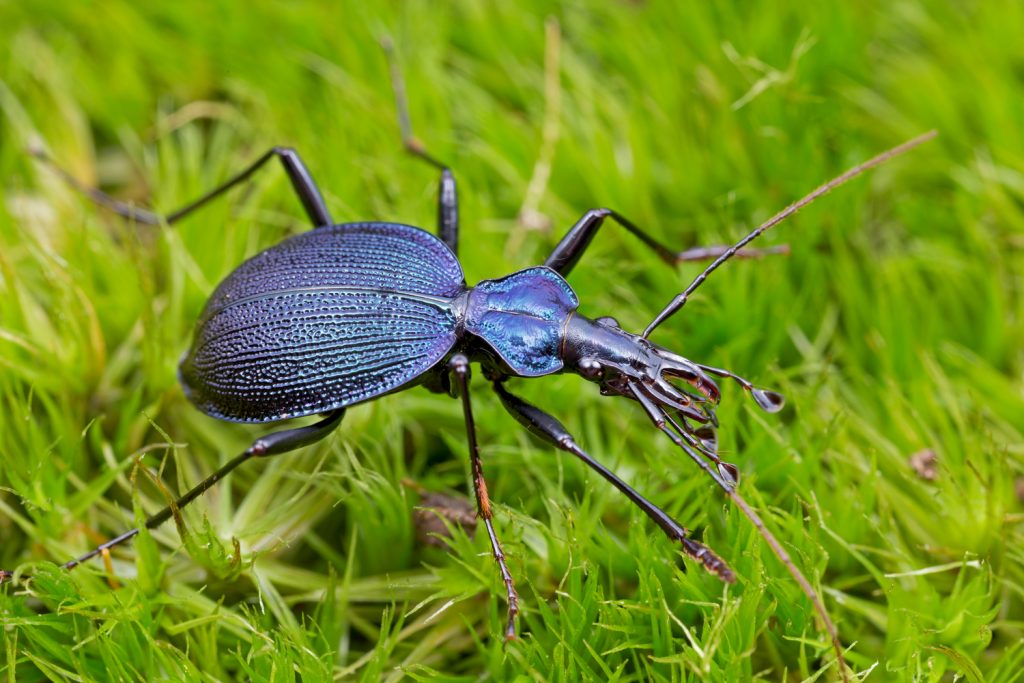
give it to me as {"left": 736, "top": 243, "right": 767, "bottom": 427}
{"left": 630, "top": 384, "right": 850, "bottom": 681}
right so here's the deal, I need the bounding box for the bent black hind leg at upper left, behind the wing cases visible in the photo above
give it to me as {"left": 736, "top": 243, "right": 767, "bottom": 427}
{"left": 29, "top": 147, "right": 334, "bottom": 227}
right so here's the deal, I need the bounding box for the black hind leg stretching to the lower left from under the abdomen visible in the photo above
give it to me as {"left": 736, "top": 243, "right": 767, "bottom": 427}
{"left": 14, "top": 409, "right": 345, "bottom": 580}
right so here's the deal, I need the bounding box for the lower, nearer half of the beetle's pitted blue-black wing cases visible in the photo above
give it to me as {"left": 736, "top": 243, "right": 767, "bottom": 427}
{"left": 181, "top": 289, "right": 456, "bottom": 422}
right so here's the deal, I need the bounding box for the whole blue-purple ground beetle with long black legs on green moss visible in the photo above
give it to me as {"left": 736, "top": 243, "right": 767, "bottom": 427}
{"left": 0, "top": 44, "right": 935, "bottom": 677}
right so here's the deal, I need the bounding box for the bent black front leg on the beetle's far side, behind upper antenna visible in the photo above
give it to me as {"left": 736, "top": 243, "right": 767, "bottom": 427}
{"left": 544, "top": 209, "right": 790, "bottom": 278}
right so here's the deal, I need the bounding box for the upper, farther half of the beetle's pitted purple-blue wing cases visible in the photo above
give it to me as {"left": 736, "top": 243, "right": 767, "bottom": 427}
{"left": 203, "top": 223, "right": 465, "bottom": 318}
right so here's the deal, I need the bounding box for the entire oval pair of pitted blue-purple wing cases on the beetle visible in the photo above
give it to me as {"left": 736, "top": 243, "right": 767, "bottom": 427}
{"left": 180, "top": 223, "right": 465, "bottom": 422}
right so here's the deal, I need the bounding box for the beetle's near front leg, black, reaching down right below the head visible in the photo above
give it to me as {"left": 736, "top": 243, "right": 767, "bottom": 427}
{"left": 495, "top": 382, "right": 736, "bottom": 584}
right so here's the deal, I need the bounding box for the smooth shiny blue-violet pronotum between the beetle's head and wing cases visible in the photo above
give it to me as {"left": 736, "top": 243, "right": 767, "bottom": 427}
{"left": 466, "top": 266, "right": 580, "bottom": 377}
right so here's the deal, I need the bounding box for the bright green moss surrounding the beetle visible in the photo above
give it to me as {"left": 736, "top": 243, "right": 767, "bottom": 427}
{"left": 0, "top": 0, "right": 1024, "bottom": 683}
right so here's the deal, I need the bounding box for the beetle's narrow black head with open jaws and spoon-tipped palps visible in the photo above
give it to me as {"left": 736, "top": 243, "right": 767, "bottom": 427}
{"left": 562, "top": 313, "right": 784, "bottom": 480}
